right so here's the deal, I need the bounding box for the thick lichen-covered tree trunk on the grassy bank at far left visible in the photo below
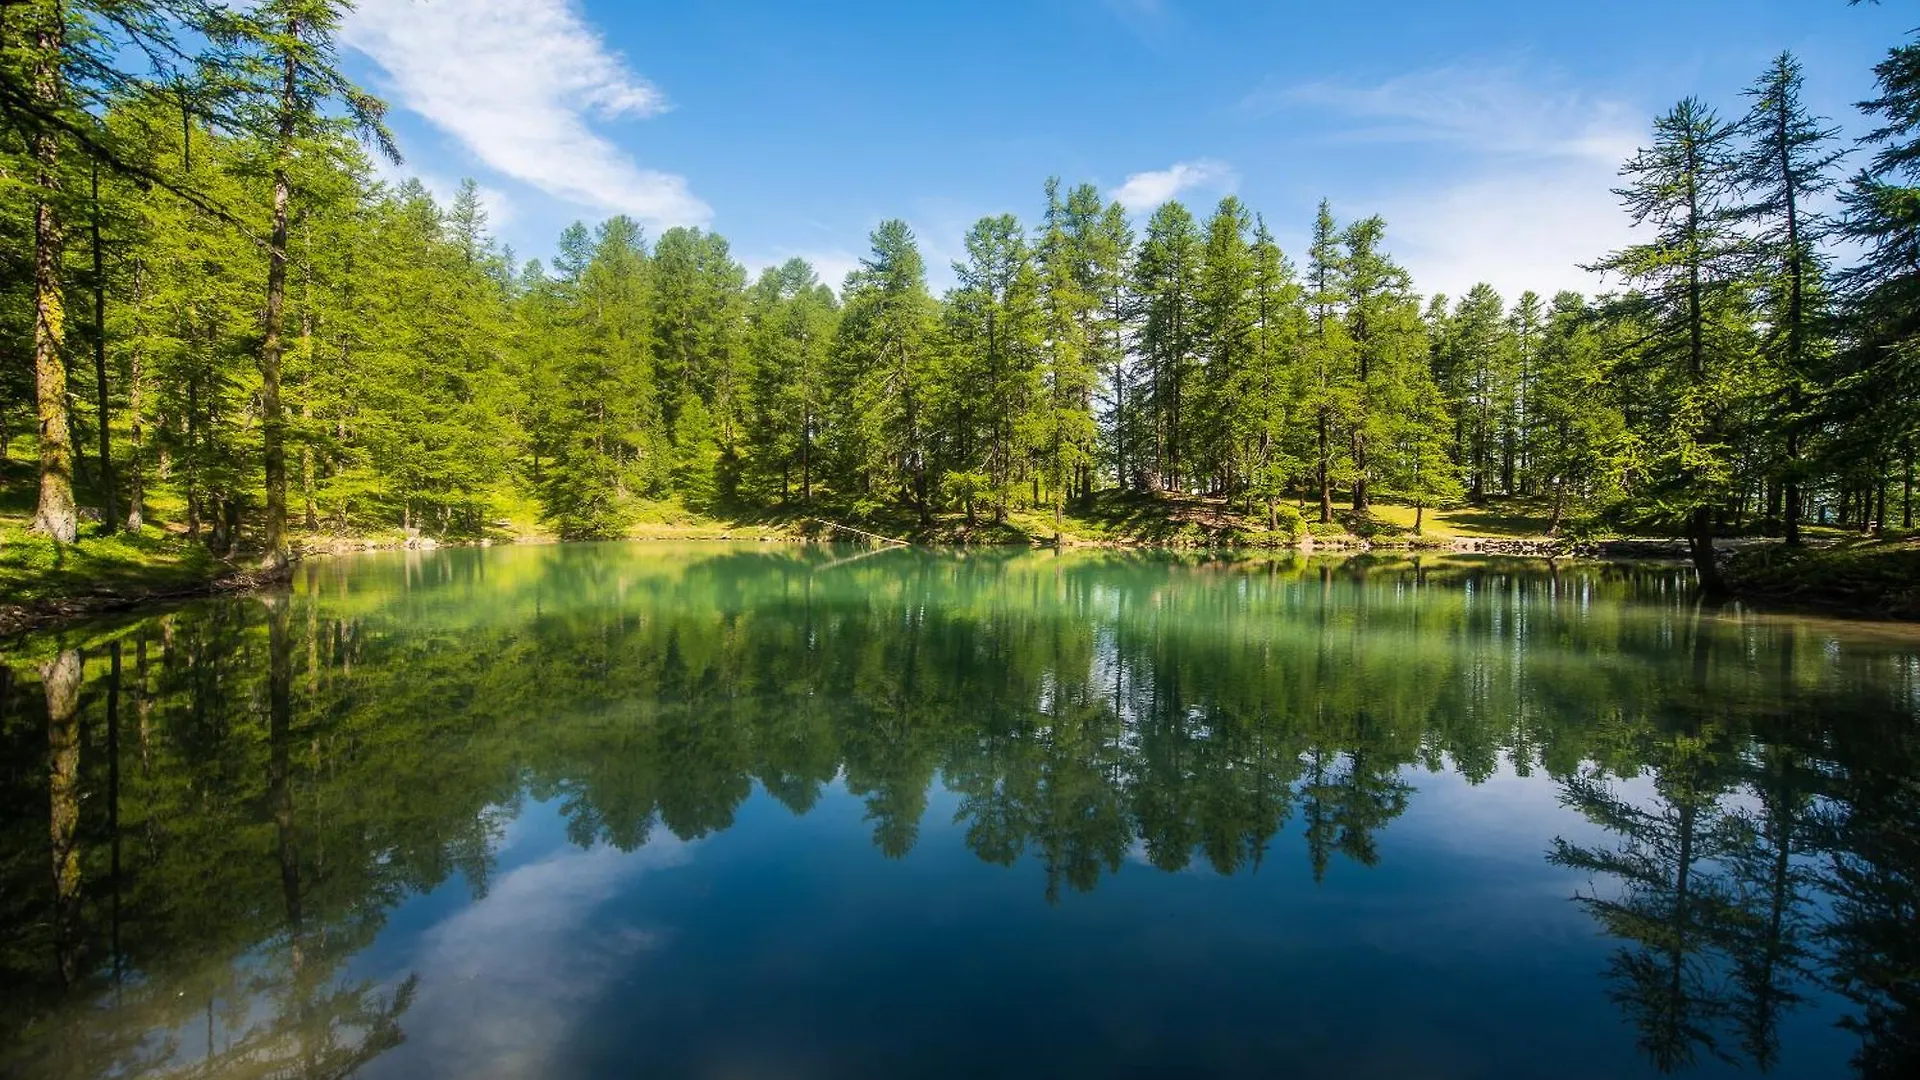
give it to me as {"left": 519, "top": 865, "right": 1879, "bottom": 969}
{"left": 33, "top": 2, "right": 81, "bottom": 544}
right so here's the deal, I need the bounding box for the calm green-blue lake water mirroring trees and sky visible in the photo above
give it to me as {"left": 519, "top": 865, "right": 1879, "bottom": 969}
{"left": 0, "top": 544, "right": 1920, "bottom": 1080}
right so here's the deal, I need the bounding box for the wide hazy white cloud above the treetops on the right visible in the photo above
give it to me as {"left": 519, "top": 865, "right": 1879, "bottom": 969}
{"left": 1242, "top": 65, "right": 1644, "bottom": 302}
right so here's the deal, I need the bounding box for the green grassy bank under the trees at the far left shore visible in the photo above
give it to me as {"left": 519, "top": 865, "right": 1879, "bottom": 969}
{"left": 0, "top": 521, "right": 221, "bottom": 603}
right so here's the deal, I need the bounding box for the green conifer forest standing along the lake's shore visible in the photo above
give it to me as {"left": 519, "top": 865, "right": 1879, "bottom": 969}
{"left": 0, "top": 0, "right": 1920, "bottom": 588}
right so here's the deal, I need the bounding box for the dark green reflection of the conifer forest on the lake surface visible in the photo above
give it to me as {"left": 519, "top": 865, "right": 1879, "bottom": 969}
{"left": 0, "top": 546, "right": 1920, "bottom": 1076}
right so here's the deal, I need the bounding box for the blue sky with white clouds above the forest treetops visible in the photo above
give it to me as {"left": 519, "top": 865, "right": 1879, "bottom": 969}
{"left": 346, "top": 0, "right": 1920, "bottom": 298}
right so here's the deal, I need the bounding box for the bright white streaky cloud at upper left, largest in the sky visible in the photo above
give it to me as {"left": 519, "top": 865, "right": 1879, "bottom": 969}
{"left": 342, "top": 0, "right": 712, "bottom": 227}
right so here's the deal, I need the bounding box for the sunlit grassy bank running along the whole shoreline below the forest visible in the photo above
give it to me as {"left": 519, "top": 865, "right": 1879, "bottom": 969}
{"left": 11, "top": 474, "right": 1920, "bottom": 630}
